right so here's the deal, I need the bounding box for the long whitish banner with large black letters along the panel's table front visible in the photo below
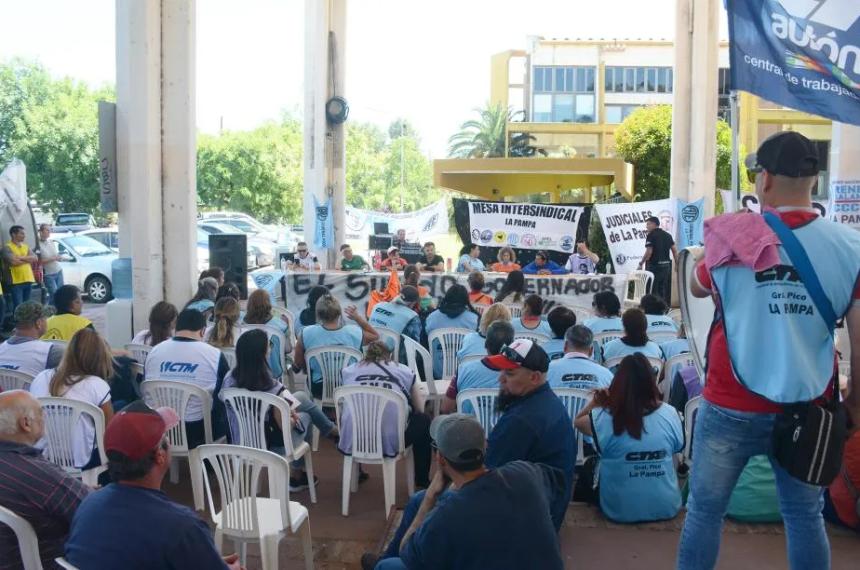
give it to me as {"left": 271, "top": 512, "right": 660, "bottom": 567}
{"left": 286, "top": 272, "right": 627, "bottom": 315}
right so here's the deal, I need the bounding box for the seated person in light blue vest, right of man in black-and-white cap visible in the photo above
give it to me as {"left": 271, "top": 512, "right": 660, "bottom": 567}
{"left": 546, "top": 325, "right": 612, "bottom": 390}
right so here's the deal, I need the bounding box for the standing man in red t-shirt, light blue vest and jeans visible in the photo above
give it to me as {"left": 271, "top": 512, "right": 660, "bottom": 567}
{"left": 678, "top": 132, "right": 860, "bottom": 570}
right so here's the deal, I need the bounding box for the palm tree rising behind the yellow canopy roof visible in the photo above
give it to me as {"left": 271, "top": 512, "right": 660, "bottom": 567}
{"left": 448, "top": 104, "right": 546, "bottom": 158}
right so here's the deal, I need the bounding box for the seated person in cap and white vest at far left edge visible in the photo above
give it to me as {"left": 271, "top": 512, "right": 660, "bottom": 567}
{"left": 0, "top": 301, "right": 63, "bottom": 376}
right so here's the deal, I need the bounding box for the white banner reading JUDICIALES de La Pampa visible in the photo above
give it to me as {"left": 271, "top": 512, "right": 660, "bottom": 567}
{"left": 597, "top": 198, "right": 678, "bottom": 273}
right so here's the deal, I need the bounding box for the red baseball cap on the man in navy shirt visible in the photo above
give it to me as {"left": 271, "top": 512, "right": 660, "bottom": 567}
{"left": 105, "top": 400, "right": 179, "bottom": 460}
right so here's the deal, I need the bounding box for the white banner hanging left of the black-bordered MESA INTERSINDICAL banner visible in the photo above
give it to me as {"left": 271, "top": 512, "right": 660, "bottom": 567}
{"left": 345, "top": 198, "right": 448, "bottom": 243}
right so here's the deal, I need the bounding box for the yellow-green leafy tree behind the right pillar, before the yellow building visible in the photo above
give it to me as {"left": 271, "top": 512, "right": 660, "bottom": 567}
{"left": 615, "top": 105, "right": 732, "bottom": 200}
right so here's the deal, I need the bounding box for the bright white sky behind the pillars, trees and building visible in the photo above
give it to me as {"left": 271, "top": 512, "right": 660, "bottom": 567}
{"left": 0, "top": 0, "right": 725, "bottom": 158}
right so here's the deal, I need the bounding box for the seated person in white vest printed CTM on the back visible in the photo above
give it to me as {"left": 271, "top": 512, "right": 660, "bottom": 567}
{"left": 144, "top": 309, "right": 230, "bottom": 448}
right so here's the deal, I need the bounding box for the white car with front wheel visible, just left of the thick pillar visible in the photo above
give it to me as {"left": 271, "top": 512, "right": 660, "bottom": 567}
{"left": 51, "top": 235, "right": 118, "bottom": 303}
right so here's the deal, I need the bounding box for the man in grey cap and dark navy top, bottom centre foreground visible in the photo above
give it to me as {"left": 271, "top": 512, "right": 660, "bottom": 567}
{"left": 376, "top": 414, "right": 565, "bottom": 570}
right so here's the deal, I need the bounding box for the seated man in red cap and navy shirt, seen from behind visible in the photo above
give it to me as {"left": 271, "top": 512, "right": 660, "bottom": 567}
{"left": 65, "top": 401, "right": 239, "bottom": 570}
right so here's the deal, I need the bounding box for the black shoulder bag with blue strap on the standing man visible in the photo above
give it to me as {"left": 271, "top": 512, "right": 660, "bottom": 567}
{"left": 764, "top": 212, "right": 848, "bottom": 487}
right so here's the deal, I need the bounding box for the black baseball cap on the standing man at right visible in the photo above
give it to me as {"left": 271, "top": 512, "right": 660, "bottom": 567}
{"left": 745, "top": 131, "right": 819, "bottom": 178}
